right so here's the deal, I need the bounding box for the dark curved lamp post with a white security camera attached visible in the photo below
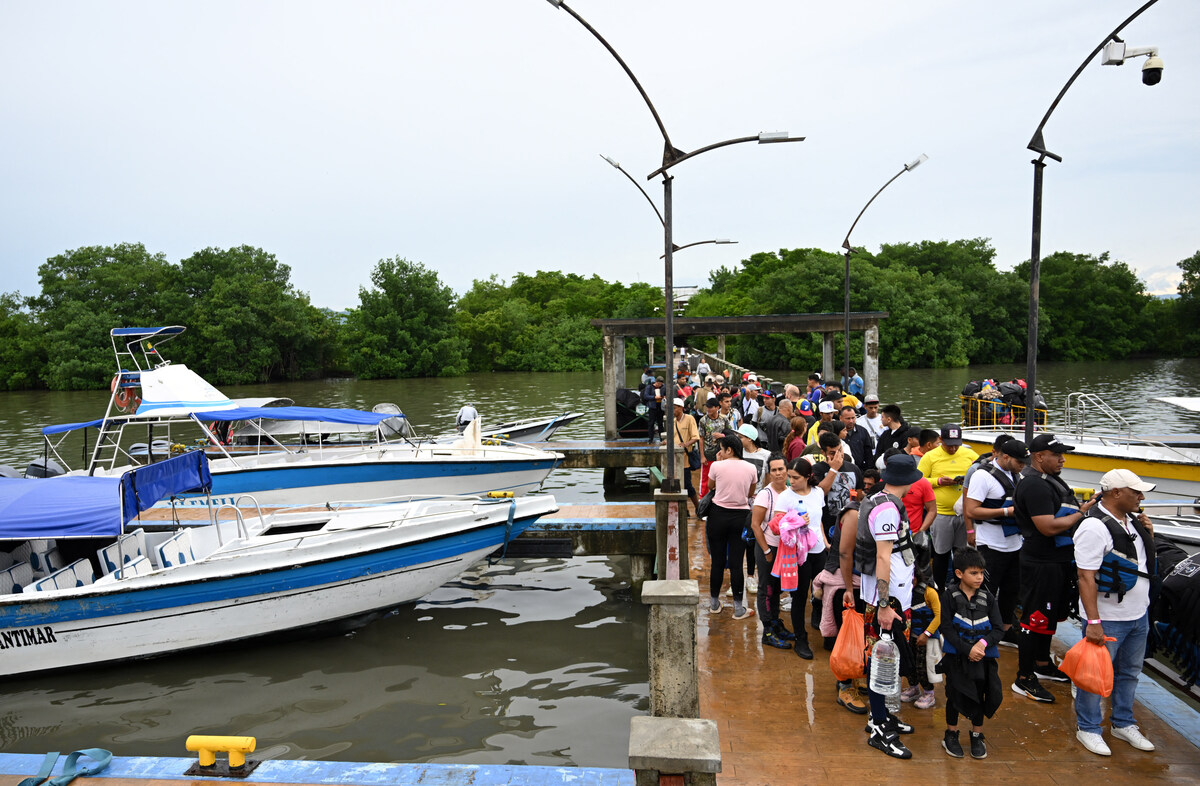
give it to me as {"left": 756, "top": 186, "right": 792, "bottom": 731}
{"left": 1025, "top": 0, "right": 1163, "bottom": 444}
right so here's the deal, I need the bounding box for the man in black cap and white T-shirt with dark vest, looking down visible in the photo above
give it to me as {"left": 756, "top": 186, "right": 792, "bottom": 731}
{"left": 962, "top": 437, "right": 1030, "bottom": 646}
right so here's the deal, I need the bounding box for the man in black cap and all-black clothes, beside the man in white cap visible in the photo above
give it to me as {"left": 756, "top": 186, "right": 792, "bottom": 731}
{"left": 1008, "top": 434, "right": 1096, "bottom": 702}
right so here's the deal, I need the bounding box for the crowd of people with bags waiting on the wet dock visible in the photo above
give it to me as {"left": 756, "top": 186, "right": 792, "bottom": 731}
{"left": 646, "top": 367, "right": 1154, "bottom": 758}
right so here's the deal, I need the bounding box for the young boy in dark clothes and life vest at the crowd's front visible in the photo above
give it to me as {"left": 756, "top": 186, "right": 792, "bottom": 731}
{"left": 940, "top": 547, "right": 1004, "bottom": 758}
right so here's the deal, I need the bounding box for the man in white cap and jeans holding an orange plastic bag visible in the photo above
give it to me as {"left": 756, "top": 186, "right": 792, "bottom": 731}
{"left": 1075, "top": 469, "right": 1156, "bottom": 756}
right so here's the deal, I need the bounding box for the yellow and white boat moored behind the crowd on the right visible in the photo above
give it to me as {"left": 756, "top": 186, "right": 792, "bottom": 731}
{"left": 962, "top": 392, "right": 1200, "bottom": 500}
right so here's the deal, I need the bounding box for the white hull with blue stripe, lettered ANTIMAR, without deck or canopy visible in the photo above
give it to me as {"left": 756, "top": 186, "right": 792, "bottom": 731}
{"left": 0, "top": 506, "right": 538, "bottom": 676}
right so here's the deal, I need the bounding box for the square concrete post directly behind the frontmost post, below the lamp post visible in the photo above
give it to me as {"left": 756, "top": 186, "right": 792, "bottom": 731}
{"left": 635, "top": 581, "right": 700, "bottom": 720}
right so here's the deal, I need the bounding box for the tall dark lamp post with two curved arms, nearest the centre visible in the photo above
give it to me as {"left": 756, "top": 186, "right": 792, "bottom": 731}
{"left": 546, "top": 0, "right": 804, "bottom": 492}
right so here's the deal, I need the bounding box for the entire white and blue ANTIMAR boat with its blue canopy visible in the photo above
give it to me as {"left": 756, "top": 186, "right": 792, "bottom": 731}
{"left": 0, "top": 450, "right": 557, "bottom": 676}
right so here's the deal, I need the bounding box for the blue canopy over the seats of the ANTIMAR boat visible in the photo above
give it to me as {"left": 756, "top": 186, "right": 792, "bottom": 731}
{"left": 0, "top": 450, "right": 212, "bottom": 540}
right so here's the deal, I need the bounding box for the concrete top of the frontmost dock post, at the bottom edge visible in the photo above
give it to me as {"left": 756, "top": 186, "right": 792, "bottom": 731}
{"left": 629, "top": 715, "right": 720, "bottom": 786}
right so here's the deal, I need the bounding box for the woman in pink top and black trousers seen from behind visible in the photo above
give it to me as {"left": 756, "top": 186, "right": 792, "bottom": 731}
{"left": 704, "top": 436, "right": 758, "bottom": 619}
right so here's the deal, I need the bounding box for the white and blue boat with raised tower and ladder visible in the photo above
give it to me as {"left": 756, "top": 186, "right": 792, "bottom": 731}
{"left": 42, "top": 325, "right": 563, "bottom": 505}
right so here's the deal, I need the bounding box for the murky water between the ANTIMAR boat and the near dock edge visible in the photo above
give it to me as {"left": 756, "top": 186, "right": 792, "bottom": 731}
{"left": 0, "top": 557, "right": 647, "bottom": 767}
